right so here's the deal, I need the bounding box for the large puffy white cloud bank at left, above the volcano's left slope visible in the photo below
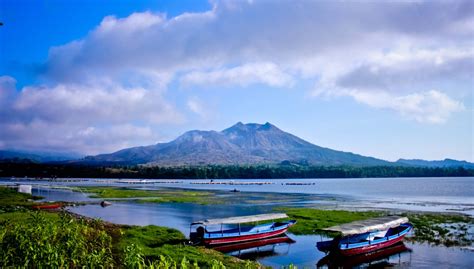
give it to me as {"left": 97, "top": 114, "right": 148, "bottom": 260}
{"left": 0, "top": 77, "right": 183, "bottom": 154}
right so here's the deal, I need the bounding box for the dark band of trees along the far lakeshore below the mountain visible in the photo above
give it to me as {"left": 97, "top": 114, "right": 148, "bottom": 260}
{"left": 0, "top": 162, "right": 474, "bottom": 179}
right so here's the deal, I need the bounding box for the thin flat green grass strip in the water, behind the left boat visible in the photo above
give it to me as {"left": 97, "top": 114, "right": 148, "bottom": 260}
{"left": 76, "top": 187, "right": 221, "bottom": 204}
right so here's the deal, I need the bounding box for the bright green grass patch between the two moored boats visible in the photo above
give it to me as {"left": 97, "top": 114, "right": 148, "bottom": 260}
{"left": 277, "top": 208, "right": 384, "bottom": 235}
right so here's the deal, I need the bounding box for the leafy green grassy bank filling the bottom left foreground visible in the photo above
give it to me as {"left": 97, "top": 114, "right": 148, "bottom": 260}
{"left": 0, "top": 187, "right": 261, "bottom": 268}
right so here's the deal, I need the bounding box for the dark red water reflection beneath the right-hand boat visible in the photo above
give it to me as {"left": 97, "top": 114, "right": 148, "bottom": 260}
{"left": 316, "top": 242, "right": 412, "bottom": 268}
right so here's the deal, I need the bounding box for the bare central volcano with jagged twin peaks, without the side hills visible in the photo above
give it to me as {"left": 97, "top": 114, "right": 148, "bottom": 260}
{"left": 81, "top": 122, "right": 392, "bottom": 166}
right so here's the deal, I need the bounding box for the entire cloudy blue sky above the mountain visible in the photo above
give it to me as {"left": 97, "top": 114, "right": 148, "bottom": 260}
{"left": 0, "top": 0, "right": 474, "bottom": 162}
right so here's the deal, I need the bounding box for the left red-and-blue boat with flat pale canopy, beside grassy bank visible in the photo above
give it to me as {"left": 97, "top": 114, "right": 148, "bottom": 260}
{"left": 189, "top": 213, "right": 296, "bottom": 246}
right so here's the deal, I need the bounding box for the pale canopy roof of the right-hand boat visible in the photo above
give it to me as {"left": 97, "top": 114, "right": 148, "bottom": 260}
{"left": 323, "top": 216, "right": 408, "bottom": 236}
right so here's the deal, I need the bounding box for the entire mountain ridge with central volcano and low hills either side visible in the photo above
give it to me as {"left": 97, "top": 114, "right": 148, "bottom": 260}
{"left": 0, "top": 122, "right": 474, "bottom": 169}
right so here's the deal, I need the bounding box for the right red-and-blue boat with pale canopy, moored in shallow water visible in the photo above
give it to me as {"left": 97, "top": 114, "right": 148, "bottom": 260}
{"left": 316, "top": 216, "right": 413, "bottom": 256}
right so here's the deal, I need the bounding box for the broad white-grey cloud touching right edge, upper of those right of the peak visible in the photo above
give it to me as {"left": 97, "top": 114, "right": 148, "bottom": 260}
{"left": 336, "top": 49, "right": 474, "bottom": 92}
